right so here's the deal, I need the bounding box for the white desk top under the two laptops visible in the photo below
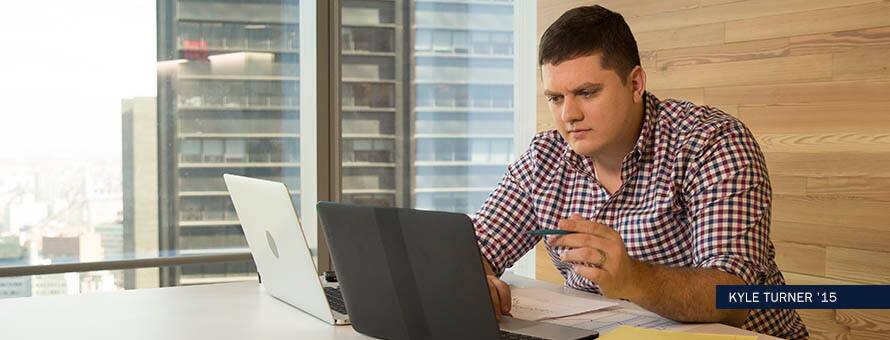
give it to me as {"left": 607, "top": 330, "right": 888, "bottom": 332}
{"left": 0, "top": 277, "right": 774, "bottom": 340}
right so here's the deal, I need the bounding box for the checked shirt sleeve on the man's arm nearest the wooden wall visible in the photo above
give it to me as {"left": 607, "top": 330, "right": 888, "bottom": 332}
{"left": 685, "top": 124, "right": 771, "bottom": 284}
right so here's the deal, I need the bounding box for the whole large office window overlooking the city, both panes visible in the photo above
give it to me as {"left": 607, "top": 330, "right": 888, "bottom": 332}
{"left": 0, "top": 0, "right": 534, "bottom": 297}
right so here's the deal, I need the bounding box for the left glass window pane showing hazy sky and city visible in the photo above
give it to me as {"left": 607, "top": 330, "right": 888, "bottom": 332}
{"left": 0, "top": 0, "right": 312, "bottom": 298}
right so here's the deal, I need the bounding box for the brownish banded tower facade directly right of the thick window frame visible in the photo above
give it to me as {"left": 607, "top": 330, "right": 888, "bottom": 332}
{"left": 340, "top": 0, "right": 410, "bottom": 206}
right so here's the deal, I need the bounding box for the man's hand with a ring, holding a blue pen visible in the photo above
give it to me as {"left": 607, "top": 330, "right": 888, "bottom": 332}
{"left": 548, "top": 214, "right": 643, "bottom": 300}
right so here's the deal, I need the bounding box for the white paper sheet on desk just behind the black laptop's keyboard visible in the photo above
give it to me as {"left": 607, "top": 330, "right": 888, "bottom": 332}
{"left": 510, "top": 288, "right": 617, "bottom": 321}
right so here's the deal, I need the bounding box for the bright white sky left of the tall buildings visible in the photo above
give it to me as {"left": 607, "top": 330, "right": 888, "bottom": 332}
{"left": 0, "top": 0, "right": 157, "bottom": 162}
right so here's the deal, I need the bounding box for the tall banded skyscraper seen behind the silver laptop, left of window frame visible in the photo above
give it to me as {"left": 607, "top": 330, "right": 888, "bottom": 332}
{"left": 158, "top": 0, "right": 300, "bottom": 285}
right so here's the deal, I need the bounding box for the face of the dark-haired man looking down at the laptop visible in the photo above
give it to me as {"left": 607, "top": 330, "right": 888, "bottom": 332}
{"left": 541, "top": 53, "right": 641, "bottom": 157}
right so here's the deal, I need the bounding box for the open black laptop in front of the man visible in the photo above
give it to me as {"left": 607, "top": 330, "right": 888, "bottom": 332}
{"left": 317, "top": 202, "right": 597, "bottom": 339}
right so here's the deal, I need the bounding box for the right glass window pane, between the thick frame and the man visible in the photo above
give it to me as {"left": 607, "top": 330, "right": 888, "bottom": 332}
{"left": 341, "top": 0, "right": 515, "bottom": 214}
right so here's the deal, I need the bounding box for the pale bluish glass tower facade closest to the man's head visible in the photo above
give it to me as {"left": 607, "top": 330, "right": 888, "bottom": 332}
{"left": 408, "top": 0, "right": 515, "bottom": 214}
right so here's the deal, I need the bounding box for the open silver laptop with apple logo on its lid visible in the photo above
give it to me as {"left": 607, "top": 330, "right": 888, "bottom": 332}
{"left": 223, "top": 174, "right": 349, "bottom": 325}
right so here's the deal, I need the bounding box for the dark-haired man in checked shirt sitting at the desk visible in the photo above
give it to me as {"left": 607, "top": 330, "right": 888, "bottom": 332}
{"left": 474, "top": 6, "right": 808, "bottom": 338}
